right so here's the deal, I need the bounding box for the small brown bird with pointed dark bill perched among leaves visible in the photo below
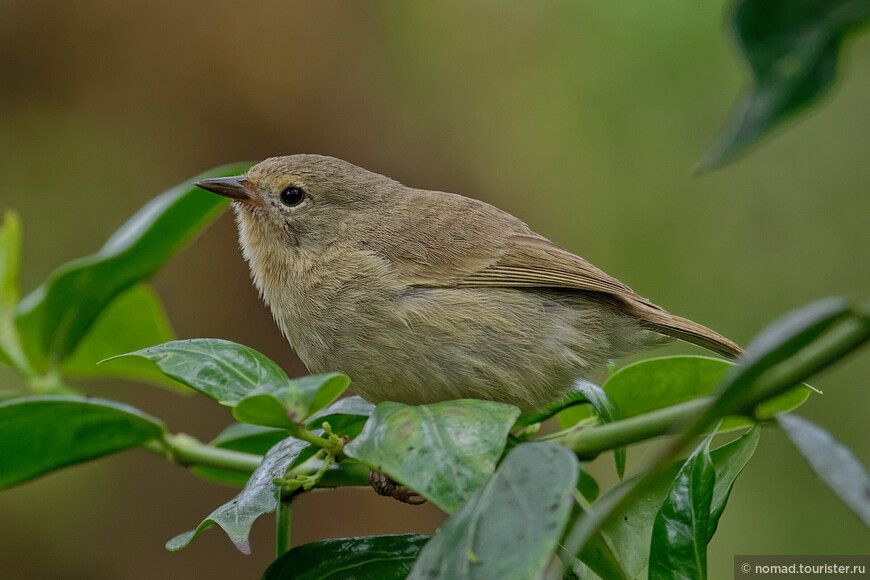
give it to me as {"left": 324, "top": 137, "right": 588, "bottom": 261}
{"left": 197, "top": 155, "right": 742, "bottom": 410}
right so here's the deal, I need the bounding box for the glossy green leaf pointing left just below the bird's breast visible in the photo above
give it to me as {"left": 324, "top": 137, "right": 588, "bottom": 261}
{"left": 109, "top": 338, "right": 290, "bottom": 407}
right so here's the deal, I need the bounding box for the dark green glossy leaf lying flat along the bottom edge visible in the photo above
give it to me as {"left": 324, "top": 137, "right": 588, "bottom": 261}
{"left": 262, "top": 534, "right": 431, "bottom": 580}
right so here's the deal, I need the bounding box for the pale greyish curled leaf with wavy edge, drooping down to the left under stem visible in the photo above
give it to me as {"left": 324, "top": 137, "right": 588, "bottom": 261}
{"left": 166, "top": 437, "right": 309, "bottom": 554}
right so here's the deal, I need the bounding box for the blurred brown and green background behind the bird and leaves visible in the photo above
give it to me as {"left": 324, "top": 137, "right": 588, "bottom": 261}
{"left": 0, "top": 0, "right": 870, "bottom": 579}
